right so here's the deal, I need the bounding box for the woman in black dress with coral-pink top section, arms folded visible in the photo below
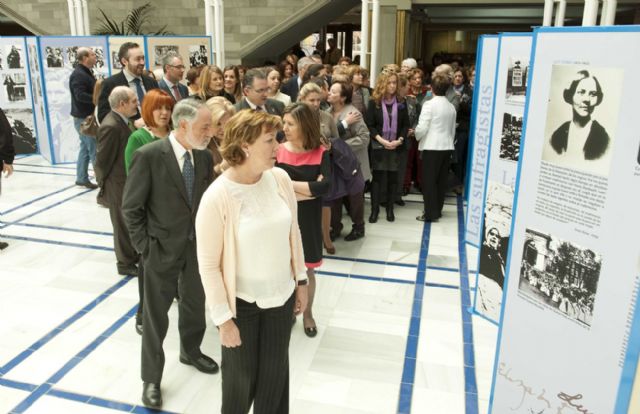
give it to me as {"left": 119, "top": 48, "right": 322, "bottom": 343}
{"left": 276, "top": 102, "right": 331, "bottom": 337}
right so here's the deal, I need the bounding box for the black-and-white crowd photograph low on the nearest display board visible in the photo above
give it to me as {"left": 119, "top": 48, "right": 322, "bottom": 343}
{"left": 518, "top": 229, "right": 602, "bottom": 326}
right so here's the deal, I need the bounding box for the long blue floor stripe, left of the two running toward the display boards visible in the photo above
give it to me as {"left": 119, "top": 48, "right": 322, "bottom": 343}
{"left": 398, "top": 223, "right": 431, "bottom": 414}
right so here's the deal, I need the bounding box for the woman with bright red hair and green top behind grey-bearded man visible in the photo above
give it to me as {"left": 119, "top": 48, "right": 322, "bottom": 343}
{"left": 124, "top": 89, "right": 174, "bottom": 335}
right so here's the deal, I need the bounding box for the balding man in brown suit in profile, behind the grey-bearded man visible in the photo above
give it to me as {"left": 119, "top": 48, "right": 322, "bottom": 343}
{"left": 95, "top": 86, "right": 138, "bottom": 275}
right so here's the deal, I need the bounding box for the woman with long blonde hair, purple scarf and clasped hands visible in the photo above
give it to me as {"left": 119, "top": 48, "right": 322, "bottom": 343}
{"left": 366, "top": 72, "right": 409, "bottom": 223}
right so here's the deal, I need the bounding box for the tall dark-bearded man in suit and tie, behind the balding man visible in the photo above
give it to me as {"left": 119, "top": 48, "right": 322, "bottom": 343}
{"left": 98, "top": 42, "right": 158, "bottom": 124}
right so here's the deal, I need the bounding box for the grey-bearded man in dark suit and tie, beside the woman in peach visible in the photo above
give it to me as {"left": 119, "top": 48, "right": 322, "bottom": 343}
{"left": 122, "top": 99, "right": 220, "bottom": 408}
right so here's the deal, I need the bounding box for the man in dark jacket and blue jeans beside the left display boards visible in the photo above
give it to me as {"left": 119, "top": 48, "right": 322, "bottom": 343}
{"left": 69, "top": 47, "right": 98, "bottom": 189}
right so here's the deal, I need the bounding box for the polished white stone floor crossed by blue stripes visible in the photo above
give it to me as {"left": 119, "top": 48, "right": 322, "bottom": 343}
{"left": 0, "top": 155, "right": 497, "bottom": 414}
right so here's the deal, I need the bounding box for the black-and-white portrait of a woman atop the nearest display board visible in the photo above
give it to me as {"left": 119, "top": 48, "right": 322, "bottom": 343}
{"left": 542, "top": 65, "right": 623, "bottom": 176}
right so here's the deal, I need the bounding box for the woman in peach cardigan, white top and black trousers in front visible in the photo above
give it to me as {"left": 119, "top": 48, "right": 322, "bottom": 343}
{"left": 196, "top": 110, "right": 308, "bottom": 414}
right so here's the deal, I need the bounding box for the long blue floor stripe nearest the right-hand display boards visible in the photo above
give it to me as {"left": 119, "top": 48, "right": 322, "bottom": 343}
{"left": 457, "top": 197, "right": 478, "bottom": 414}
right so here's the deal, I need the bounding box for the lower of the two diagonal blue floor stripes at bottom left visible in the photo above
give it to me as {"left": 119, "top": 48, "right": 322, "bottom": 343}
{"left": 10, "top": 304, "right": 138, "bottom": 414}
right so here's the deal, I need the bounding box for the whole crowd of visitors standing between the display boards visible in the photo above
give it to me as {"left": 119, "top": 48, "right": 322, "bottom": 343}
{"left": 4, "top": 42, "right": 473, "bottom": 413}
